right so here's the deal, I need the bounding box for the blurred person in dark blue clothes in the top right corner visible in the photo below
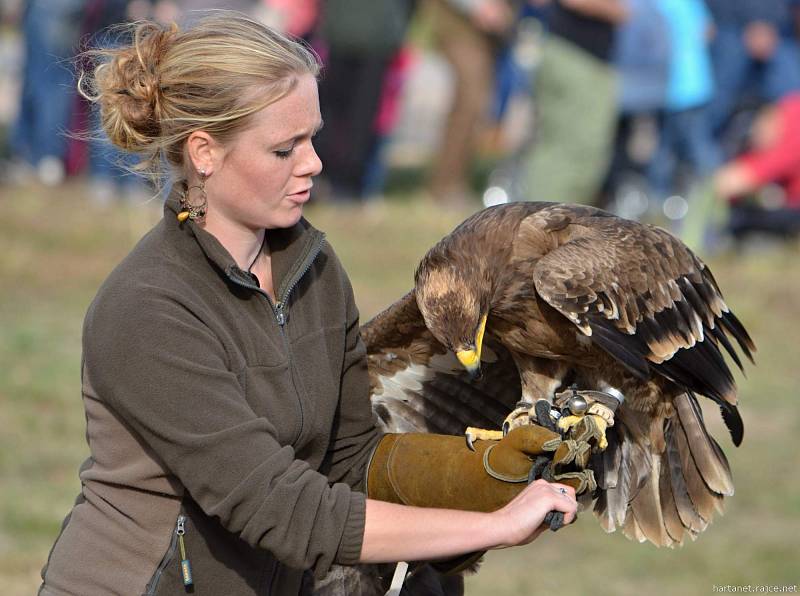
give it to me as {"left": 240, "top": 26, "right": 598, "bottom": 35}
{"left": 706, "top": 0, "right": 800, "bottom": 146}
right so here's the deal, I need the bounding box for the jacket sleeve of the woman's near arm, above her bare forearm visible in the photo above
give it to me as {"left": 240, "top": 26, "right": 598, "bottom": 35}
{"left": 84, "top": 272, "right": 365, "bottom": 577}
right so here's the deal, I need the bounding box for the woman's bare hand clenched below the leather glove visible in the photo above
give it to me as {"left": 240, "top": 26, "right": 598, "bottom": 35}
{"left": 489, "top": 480, "right": 578, "bottom": 548}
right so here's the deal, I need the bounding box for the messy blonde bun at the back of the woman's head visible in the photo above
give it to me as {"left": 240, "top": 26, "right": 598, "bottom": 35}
{"left": 96, "top": 22, "right": 177, "bottom": 151}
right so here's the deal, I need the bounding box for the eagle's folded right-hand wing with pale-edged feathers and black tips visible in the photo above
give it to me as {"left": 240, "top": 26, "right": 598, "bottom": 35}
{"left": 532, "top": 206, "right": 755, "bottom": 424}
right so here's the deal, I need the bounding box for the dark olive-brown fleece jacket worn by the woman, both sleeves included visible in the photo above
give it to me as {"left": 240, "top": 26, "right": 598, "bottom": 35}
{"left": 40, "top": 194, "right": 379, "bottom": 596}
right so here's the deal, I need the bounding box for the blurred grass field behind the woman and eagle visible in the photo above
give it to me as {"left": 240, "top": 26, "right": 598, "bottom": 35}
{"left": 0, "top": 184, "right": 800, "bottom": 596}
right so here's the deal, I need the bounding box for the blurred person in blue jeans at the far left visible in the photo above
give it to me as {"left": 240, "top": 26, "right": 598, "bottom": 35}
{"left": 10, "top": 0, "right": 89, "bottom": 185}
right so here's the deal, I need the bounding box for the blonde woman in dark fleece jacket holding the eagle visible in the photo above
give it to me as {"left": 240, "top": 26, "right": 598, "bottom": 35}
{"left": 40, "top": 13, "right": 576, "bottom": 595}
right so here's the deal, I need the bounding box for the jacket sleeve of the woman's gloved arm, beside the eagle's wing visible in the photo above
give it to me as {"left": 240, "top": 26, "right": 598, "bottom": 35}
{"left": 327, "top": 271, "right": 381, "bottom": 492}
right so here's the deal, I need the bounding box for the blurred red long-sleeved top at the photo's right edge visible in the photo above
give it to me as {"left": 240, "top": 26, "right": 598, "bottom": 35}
{"left": 736, "top": 93, "right": 800, "bottom": 209}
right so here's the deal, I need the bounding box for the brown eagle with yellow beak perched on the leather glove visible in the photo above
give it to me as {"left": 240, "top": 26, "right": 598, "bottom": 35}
{"left": 362, "top": 203, "right": 755, "bottom": 546}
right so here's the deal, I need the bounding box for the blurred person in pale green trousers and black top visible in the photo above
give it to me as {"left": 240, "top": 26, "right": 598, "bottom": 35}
{"left": 519, "top": 0, "right": 628, "bottom": 203}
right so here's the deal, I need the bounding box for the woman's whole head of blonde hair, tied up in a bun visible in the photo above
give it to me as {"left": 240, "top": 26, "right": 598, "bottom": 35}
{"left": 78, "top": 11, "right": 319, "bottom": 183}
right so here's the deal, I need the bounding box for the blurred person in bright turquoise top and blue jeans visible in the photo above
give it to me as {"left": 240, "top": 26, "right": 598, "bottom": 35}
{"left": 649, "top": 0, "right": 722, "bottom": 214}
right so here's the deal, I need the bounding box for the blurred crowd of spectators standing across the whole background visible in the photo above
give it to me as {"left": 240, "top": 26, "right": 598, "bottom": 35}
{"left": 0, "top": 0, "right": 800, "bottom": 248}
